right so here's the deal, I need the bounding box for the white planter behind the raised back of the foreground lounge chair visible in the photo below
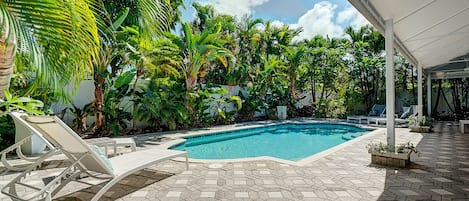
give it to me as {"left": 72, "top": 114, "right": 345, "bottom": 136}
{"left": 13, "top": 115, "right": 46, "bottom": 155}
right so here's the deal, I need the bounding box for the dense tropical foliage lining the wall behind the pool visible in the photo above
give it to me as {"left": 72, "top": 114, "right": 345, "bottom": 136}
{"left": 5, "top": 0, "right": 467, "bottom": 141}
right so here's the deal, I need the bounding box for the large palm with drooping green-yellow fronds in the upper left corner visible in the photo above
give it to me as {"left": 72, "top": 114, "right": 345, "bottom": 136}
{"left": 0, "top": 0, "right": 99, "bottom": 97}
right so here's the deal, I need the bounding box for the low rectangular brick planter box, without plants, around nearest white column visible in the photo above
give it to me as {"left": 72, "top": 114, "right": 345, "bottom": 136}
{"left": 368, "top": 150, "right": 411, "bottom": 168}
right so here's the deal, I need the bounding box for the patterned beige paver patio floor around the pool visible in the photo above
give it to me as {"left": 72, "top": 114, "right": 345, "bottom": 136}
{"left": 0, "top": 122, "right": 469, "bottom": 201}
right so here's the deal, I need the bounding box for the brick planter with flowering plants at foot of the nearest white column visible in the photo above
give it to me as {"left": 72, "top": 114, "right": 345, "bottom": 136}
{"left": 367, "top": 142, "right": 419, "bottom": 167}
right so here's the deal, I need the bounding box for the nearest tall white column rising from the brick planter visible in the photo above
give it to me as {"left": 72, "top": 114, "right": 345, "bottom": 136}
{"left": 384, "top": 19, "right": 396, "bottom": 146}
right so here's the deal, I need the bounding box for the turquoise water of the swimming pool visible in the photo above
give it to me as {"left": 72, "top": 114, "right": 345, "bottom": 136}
{"left": 172, "top": 123, "right": 368, "bottom": 161}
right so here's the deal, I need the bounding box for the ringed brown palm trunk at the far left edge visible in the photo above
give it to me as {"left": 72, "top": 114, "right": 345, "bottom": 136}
{"left": 0, "top": 28, "right": 16, "bottom": 98}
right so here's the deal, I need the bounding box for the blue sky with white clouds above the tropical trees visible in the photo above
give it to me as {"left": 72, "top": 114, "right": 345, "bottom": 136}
{"left": 183, "top": 0, "right": 369, "bottom": 39}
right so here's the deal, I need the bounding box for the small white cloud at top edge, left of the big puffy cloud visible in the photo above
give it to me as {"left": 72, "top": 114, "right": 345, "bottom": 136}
{"left": 208, "top": 0, "right": 269, "bottom": 16}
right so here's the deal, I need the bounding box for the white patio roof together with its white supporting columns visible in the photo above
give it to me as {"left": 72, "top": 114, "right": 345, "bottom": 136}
{"left": 348, "top": 0, "right": 469, "bottom": 146}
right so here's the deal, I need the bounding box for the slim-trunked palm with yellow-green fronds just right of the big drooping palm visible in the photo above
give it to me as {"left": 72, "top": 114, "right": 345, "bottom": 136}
{"left": 93, "top": 0, "right": 173, "bottom": 133}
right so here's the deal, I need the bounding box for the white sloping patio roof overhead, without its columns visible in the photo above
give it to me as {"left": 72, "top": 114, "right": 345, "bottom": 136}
{"left": 349, "top": 0, "right": 469, "bottom": 78}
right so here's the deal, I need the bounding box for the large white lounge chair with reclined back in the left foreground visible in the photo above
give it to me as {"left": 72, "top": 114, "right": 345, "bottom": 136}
{"left": 1, "top": 116, "right": 189, "bottom": 201}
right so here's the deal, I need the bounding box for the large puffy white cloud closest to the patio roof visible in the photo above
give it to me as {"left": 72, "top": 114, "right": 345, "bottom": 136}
{"left": 291, "top": 1, "right": 343, "bottom": 40}
